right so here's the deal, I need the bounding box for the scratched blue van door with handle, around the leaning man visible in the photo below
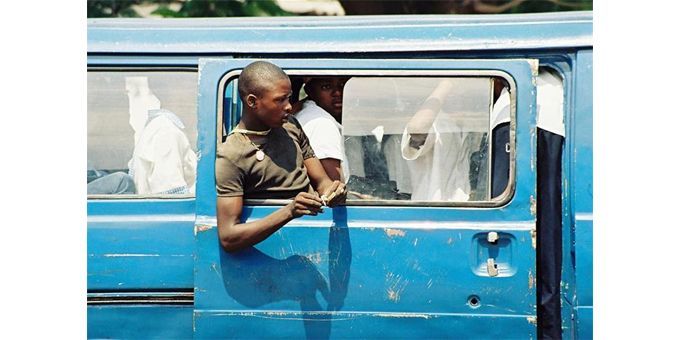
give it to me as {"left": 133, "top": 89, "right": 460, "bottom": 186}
{"left": 194, "top": 58, "right": 538, "bottom": 338}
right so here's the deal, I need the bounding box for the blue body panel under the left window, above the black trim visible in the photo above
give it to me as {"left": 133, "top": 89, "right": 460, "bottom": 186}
{"left": 87, "top": 198, "right": 195, "bottom": 291}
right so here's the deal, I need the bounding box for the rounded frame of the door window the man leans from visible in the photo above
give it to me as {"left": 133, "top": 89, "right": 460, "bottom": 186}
{"left": 215, "top": 68, "right": 517, "bottom": 208}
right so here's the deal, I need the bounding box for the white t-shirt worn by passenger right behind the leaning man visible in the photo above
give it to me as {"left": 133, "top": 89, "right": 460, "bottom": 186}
{"left": 295, "top": 99, "right": 349, "bottom": 182}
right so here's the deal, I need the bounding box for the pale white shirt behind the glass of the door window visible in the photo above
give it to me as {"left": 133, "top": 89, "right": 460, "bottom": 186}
{"left": 401, "top": 115, "right": 480, "bottom": 202}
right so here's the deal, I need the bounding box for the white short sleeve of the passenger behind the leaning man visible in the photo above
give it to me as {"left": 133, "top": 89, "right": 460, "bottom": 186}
{"left": 303, "top": 119, "right": 343, "bottom": 161}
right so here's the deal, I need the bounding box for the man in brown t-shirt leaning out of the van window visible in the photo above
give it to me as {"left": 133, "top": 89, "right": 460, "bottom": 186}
{"left": 215, "top": 61, "right": 346, "bottom": 252}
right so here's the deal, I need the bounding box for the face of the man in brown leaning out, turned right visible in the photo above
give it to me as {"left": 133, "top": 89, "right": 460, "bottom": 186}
{"left": 252, "top": 78, "right": 293, "bottom": 128}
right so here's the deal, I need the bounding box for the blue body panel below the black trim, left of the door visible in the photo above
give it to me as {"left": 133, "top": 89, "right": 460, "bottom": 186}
{"left": 87, "top": 305, "right": 193, "bottom": 339}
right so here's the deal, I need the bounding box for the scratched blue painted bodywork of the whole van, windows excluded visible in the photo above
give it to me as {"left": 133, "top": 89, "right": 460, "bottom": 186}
{"left": 88, "top": 12, "right": 593, "bottom": 338}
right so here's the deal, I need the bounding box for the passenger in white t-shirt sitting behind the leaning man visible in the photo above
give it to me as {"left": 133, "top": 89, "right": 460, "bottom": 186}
{"left": 295, "top": 77, "right": 349, "bottom": 182}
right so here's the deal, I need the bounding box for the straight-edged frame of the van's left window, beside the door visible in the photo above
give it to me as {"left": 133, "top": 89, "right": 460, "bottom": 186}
{"left": 87, "top": 66, "right": 200, "bottom": 200}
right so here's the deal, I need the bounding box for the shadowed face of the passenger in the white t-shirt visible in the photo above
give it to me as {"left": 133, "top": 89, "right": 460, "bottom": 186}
{"left": 305, "top": 77, "right": 347, "bottom": 122}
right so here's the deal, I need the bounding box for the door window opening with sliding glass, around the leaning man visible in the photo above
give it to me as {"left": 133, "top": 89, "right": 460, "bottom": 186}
{"left": 218, "top": 71, "right": 514, "bottom": 207}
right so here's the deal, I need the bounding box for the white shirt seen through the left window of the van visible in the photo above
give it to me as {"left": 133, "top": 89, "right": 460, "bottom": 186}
{"left": 130, "top": 109, "right": 196, "bottom": 195}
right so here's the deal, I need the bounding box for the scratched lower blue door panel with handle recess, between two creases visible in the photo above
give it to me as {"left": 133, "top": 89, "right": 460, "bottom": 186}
{"left": 195, "top": 226, "right": 536, "bottom": 316}
